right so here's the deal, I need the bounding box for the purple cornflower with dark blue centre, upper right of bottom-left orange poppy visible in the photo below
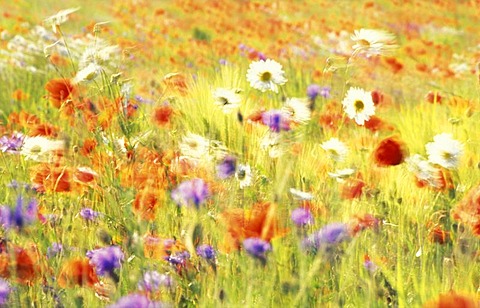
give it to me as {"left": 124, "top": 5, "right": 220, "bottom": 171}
{"left": 87, "top": 246, "right": 124, "bottom": 276}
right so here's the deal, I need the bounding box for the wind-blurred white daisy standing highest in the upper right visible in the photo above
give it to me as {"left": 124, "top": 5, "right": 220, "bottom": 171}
{"left": 351, "top": 29, "right": 398, "bottom": 57}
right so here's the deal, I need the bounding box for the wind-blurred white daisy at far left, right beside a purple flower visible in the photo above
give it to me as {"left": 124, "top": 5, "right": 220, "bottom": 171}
{"left": 20, "top": 136, "right": 65, "bottom": 162}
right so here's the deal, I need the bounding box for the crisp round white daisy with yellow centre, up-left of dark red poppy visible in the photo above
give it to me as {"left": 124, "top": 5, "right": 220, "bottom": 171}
{"left": 342, "top": 87, "right": 375, "bottom": 125}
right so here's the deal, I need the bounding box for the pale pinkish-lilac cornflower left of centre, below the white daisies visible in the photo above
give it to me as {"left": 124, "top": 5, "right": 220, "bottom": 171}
{"left": 171, "top": 179, "right": 209, "bottom": 208}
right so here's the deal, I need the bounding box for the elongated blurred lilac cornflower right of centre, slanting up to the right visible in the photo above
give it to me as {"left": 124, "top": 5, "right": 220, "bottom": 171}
{"left": 302, "top": 223, "right": 350, "bottom": 251}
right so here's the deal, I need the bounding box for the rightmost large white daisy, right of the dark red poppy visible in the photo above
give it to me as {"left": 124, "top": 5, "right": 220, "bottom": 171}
{"left": 425, "top": 133, "right": 463, "bottom": 169}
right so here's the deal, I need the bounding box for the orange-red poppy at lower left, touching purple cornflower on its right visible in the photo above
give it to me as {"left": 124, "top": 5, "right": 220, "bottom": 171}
{"left": 58, "top": 258, "right": 99, "bottom": 288}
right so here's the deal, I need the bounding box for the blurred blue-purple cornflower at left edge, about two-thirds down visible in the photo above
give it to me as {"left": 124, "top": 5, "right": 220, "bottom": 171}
{"left": 0, "top": 196, "right": 38, "bottom": 229}
